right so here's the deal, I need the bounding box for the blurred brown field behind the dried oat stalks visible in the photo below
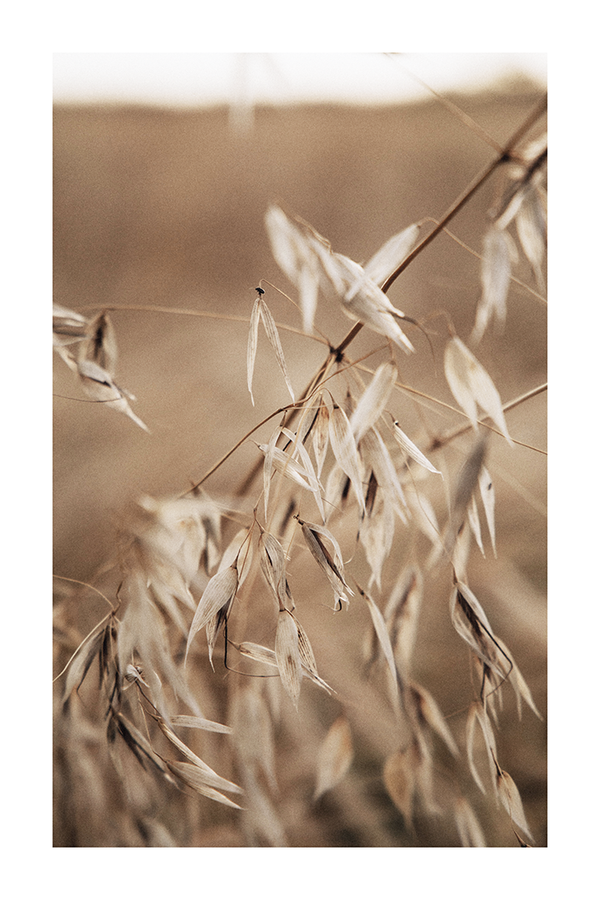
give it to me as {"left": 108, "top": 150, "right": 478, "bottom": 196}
{"left": 53, "top": 74, "right": 546, "bottom": 846}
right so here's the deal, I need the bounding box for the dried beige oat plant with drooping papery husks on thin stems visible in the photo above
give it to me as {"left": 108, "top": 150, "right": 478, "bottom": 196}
{"left": 54, "top": 81, "right": 545, "bottom": 846}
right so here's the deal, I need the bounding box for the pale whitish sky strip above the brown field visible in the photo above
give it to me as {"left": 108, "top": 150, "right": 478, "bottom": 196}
{"left": 53, "top": 52, "right": 547, "bottom": 106}
